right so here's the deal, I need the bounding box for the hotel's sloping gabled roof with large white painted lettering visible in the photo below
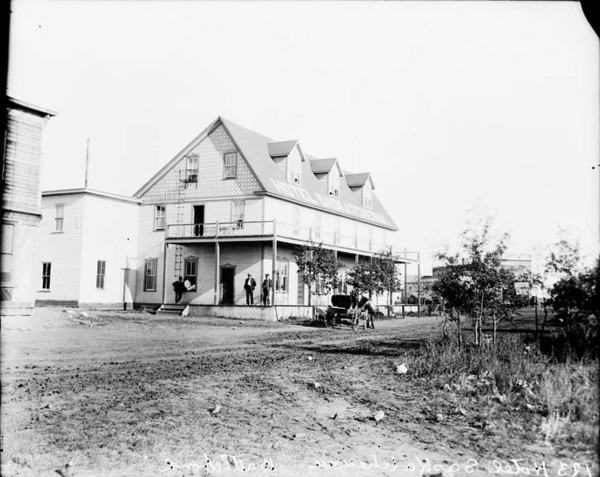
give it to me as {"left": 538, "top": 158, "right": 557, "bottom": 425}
{"left": 135, "top": 117, "right": 397, "bottom": 230}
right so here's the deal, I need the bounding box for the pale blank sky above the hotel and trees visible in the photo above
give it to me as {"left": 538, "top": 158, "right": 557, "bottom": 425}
{"left": 8, "top": 0, "right": 600, "bottom": 273}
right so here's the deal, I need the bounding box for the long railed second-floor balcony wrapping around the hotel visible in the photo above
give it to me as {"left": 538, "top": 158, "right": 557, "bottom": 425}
{"left": 166, "top": 220, "right": 408, "bottom": 253}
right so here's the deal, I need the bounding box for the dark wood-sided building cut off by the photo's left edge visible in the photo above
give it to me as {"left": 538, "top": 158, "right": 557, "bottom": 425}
{"left": 0, "top": 98, "right": 56, "bottom": 315}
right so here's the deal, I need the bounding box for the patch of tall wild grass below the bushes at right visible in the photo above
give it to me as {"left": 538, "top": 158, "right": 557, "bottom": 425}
{"left": 406, "top": 330, "right": 599, "bottom": 449}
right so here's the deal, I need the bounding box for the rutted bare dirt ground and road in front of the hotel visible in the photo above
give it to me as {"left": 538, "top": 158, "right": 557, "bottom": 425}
{"left": 1, "top": 308, "right": 597, "bottom": 476}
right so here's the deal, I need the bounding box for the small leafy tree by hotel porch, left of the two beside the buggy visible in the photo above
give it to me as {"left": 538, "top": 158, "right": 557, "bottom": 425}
{"left": 294, "top": 244, "right": 343, "bottom": 305}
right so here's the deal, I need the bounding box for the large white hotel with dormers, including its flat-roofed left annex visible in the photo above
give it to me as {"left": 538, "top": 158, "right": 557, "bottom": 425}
{"left": 36, "top": 118, "right": 414, "bottom": 318}
